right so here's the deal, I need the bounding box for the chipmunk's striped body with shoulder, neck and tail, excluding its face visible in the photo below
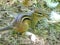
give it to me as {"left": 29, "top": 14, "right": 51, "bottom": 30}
{"left": 0, "top": 10, "right": 40, "bottom": 33}
